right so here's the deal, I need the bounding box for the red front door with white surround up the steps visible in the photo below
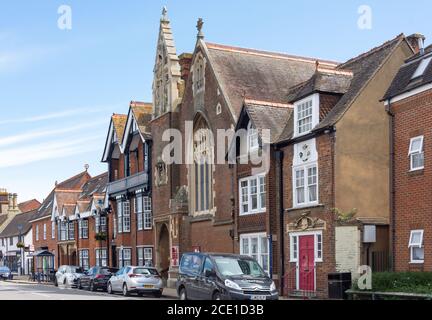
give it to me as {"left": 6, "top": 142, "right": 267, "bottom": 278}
{"left": 299, "top": 235, "right": 315, "bottom": 291}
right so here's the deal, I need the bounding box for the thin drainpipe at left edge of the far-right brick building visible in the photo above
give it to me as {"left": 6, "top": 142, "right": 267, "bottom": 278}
{"left": 386, "top": 99, "right": 396, "bottom": 271}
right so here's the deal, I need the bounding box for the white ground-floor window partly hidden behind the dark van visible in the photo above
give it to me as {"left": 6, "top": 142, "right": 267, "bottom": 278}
{"left": 240, "top": 233, "right": 270, "bottom": 274}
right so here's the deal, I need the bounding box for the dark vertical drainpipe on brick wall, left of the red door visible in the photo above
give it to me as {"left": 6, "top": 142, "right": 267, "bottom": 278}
{"left": 275, "top": 150, "right": 285, "bottom": 296}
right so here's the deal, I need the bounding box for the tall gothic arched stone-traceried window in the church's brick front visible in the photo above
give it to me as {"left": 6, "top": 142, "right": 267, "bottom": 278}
{"left": 193, "top": 117, "right": 214, "bottom": 213}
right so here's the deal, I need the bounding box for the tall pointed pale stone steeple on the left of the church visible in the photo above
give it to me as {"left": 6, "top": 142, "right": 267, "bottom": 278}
{"left": 153, "top": 7, "right": 183, "bottom": 118}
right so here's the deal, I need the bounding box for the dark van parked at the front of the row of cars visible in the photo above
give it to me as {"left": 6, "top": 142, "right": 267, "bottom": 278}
{"left": 176, "top": 253, "right": 279, "bottom": 300}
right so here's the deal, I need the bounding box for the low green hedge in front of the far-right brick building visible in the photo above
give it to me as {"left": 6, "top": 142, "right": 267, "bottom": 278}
{"left": 354, "top": 272, "right": 432, "bottom": 294}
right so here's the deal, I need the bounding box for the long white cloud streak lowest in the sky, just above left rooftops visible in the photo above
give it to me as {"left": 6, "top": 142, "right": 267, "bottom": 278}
{"left": 0, "top": 135, "right": 104, "bottom": 168}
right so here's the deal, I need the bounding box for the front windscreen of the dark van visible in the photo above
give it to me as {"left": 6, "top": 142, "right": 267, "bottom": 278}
{"left": 215, "top": 257, "right": 266, "bottom": 278}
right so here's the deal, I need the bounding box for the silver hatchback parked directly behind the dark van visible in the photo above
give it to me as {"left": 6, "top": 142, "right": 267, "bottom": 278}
{"left": 108, "top": 267, "right": 164, "bottom": 298}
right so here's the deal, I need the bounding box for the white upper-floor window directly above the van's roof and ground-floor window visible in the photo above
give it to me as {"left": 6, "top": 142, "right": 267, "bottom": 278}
{"left": 239, "top": 175, "right": 266, "bottom": 215}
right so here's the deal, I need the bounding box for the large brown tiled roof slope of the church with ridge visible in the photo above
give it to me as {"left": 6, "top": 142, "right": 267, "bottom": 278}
{"left": 200, "top": 41, "right": 338, "bottom": 119}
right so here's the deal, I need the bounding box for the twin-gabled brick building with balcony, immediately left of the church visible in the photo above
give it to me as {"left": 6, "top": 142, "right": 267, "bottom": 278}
{"left": 102, "top": 102, "right": 154, "bottom": 267}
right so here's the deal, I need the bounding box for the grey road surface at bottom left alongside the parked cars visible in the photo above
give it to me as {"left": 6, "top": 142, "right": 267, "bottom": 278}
{"left": 0, "top": 281, "right": 177, "bottom": 301}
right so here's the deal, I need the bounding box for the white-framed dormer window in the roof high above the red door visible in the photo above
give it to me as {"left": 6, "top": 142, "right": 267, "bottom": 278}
{"left": 294, "top": 94, "right": 319, "bottom": 137}
